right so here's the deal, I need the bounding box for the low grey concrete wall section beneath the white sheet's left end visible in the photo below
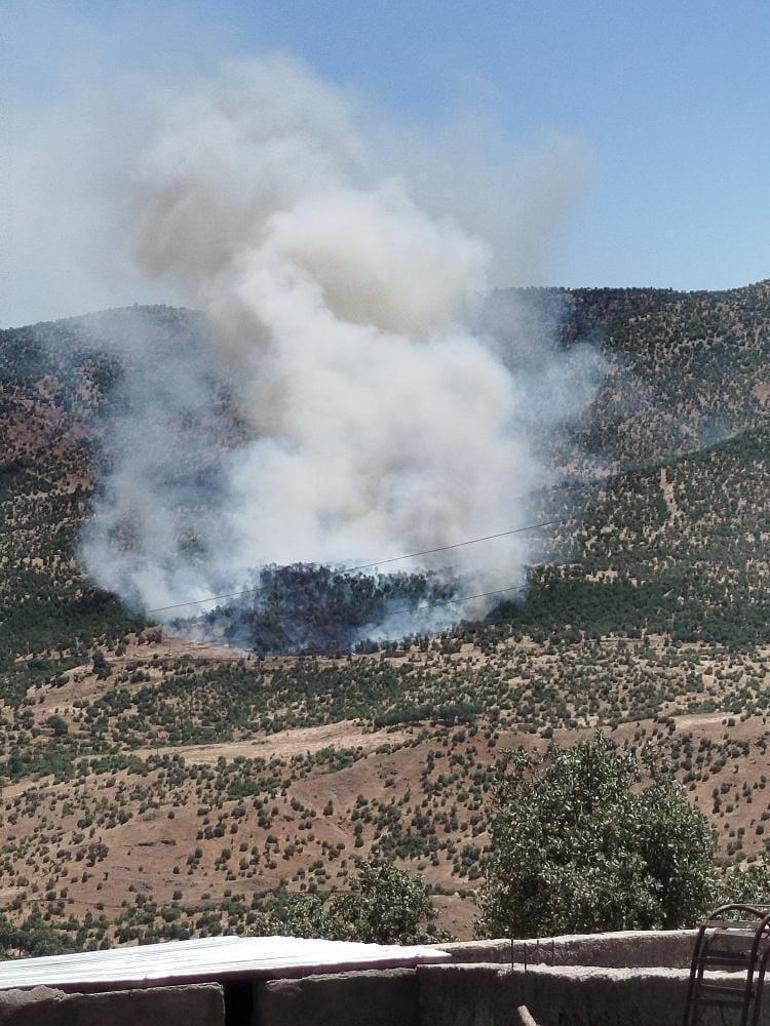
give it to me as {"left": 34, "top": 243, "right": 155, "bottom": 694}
{"left": 0, "top": 984, "right": 225, "bottom": 1026}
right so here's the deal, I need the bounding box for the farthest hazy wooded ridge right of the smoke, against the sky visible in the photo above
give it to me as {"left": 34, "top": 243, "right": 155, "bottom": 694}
{"left": 494, "top": 281, "right": 770, "bottom": 464}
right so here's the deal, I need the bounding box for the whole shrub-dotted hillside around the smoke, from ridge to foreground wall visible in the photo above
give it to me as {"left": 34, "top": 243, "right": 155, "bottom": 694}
{"left": 0, "top": 284, "right": 770, "bottom": 943}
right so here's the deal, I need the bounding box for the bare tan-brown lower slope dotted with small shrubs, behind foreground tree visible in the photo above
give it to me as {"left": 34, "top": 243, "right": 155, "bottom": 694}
{"left": 0, "top": 642, "right": 770, "bottom": 937}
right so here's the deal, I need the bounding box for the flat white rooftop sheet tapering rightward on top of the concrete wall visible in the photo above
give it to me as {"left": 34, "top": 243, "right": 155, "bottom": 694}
{"left": 0, "top": 937, "right": 452, "bottom": 990}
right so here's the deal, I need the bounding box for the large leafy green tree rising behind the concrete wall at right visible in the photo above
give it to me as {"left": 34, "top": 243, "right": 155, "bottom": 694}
{"left": 477, "top": 735, "right": 719, "bottom": 937}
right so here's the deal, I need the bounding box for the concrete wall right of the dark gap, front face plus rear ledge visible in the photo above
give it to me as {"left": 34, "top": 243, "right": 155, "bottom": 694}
{"left": 253, "top": 931, "right": 770, "bottom": 1026}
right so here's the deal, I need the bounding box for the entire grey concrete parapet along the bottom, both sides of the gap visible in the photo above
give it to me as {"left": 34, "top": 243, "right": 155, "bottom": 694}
{"left": 0, "top": 932, "right": 759, "bottom": 1026}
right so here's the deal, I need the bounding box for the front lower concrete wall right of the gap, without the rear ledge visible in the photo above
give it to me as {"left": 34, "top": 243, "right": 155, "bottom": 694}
{"left": 254, "top": 962, "right": 770, "bottom": 1026}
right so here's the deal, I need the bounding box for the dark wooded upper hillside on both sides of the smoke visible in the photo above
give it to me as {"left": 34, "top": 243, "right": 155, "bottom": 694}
{"left": 0, "top": 282, "right": 770, "bottom": 661}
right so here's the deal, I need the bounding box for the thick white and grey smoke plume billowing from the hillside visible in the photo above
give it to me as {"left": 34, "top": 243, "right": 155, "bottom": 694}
{"left": 81, "top": 57, "right": 598, "bottom": 634}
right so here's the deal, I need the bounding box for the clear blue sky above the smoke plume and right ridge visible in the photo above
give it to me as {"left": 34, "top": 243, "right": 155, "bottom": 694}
{"left": 0, "top": 0, "right": 770, "bottom": 320}
